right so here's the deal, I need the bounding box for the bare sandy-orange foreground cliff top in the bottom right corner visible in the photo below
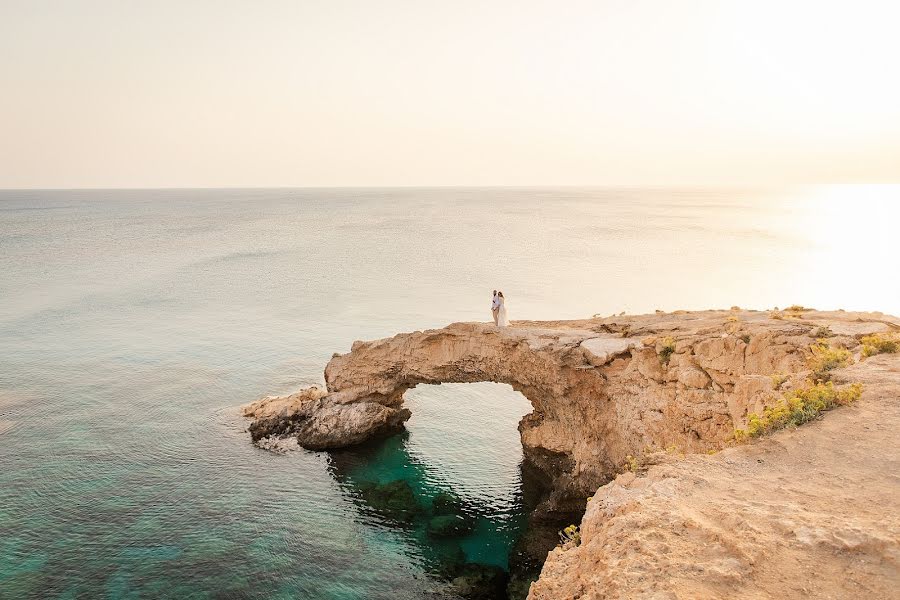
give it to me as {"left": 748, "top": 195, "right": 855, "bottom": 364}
{"left": 529, "top": 354, "right": 900, "bottom": 600}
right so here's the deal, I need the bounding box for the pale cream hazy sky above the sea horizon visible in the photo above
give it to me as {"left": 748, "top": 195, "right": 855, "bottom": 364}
{"left": 0, "top": 0, "right": 900, "bottom": 187}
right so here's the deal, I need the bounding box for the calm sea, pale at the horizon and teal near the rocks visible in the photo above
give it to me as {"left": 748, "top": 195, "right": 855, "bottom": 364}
{"left": 0, "top": 186, "right": 900, "bottom": 599}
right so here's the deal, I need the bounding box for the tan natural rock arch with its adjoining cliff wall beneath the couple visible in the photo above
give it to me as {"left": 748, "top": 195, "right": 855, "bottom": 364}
{"left": 241, "top": 311, "right": 883, "bottom": 495}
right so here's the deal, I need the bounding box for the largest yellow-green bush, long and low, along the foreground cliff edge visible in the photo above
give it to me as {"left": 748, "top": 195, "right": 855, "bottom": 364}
{"left": 734, "top": 381, "right": 862, "bottom": 442}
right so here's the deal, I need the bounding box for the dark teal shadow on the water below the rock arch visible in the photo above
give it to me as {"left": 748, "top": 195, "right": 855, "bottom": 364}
{"left": 329, "top": 431, "right": 565, "bottom": 599}
